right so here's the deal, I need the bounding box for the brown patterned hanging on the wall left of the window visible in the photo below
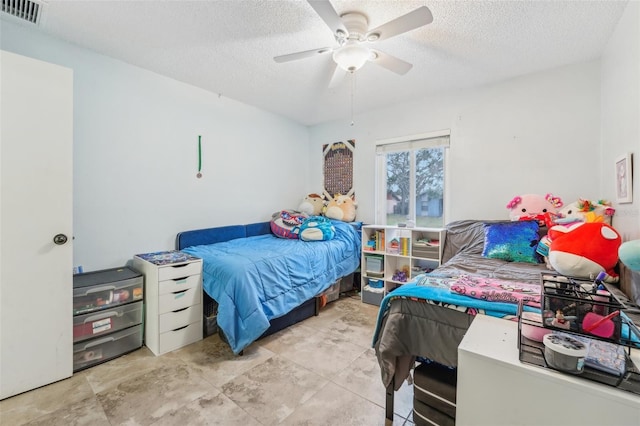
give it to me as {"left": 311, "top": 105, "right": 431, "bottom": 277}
{"left": 322, "top": 139, "right": 356, "bottom": 200}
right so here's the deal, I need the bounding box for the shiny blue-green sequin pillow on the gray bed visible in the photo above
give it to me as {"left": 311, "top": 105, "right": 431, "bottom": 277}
{"left": 482, "top": 220, "right": 540, "bottom": 263}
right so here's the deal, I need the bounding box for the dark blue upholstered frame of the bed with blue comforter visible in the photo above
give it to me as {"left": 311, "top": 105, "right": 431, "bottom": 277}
{"left": 176, "top": 222, "right": 320, "bottom": 339}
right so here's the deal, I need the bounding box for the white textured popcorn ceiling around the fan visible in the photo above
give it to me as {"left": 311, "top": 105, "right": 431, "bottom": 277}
{"left": 1, "top": 0, "right": 626, "bottom": 125}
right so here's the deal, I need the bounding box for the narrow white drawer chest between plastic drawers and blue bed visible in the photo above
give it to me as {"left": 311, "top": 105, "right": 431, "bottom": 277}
{"left": 133, "top": 251, "right": 202, "bottom": 355}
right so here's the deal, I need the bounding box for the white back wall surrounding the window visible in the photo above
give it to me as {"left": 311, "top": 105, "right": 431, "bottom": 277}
{"left": 310, "top": 61, "right": 607, "bottom": 226}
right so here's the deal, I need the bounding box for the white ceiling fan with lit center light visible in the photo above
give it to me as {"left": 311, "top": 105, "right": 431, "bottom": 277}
{"left": 273, "top": 0, "right": 433, "bottom": 88}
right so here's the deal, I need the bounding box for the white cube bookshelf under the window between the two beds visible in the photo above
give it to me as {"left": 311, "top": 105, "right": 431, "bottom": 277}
{"left": 361, "top": 225, "right": 445, "bottom": 305}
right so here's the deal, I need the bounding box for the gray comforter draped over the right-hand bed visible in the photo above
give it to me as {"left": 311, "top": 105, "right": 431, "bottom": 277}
{"left": 373, "top": 220, "right": 548, "bottom": 418}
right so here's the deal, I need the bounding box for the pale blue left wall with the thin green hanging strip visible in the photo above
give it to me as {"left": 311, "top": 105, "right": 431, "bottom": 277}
{"left": 1, "top": 21, "right": 310, "bottom": 270}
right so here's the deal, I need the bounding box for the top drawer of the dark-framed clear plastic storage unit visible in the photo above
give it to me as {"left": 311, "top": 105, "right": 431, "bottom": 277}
{"left": 73, "top": 267, "right": 144, "bottom": 315}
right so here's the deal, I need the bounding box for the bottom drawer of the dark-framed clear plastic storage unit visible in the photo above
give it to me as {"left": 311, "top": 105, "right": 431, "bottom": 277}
{"left": 73, "top": 324, "right": 142, "bottom": 372}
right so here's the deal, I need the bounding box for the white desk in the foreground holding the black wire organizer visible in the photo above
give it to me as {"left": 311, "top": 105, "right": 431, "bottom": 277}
{"left": 456, "top": 315, "right": 640, "bottom": 426}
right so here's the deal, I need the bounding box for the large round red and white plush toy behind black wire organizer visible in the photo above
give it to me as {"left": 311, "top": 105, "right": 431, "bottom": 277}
{"left": 548, "top": 222, "right": 622, "bottom": 283}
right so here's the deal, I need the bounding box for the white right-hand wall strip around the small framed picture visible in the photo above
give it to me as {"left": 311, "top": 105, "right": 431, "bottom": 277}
{"left": 600, "top": 1, "right": 640, "bottom": 240}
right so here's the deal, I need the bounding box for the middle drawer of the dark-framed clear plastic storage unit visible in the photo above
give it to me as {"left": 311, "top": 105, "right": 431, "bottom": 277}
{"left": 73, "top": 301, "right": 143, "bottom": 343}
